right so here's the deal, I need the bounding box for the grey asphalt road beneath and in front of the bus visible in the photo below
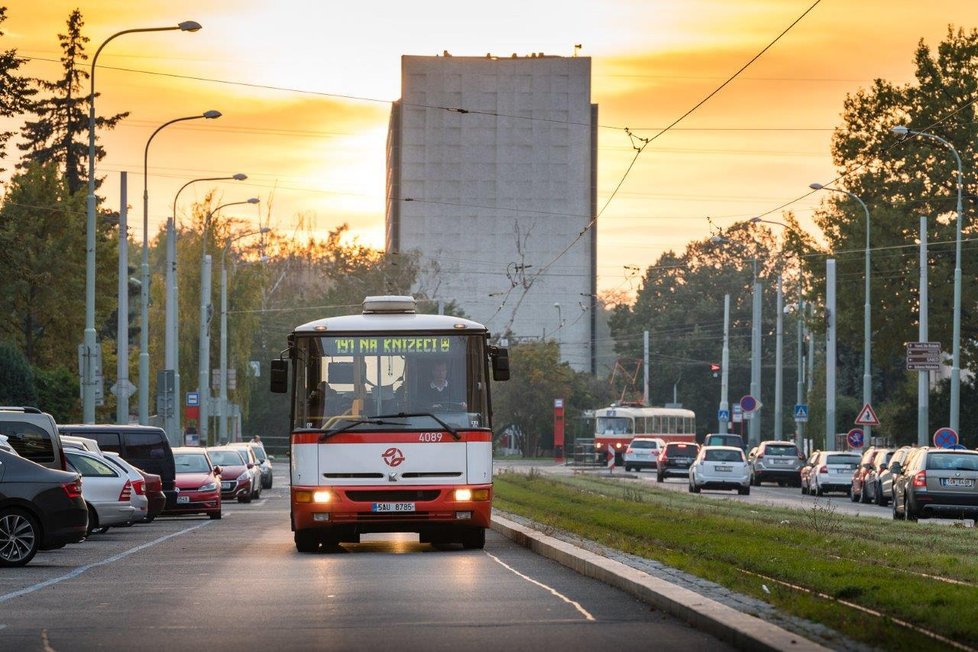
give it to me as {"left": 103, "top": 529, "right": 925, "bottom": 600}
{"left": 0, "top": 465, "right": 728, "bottom": 652}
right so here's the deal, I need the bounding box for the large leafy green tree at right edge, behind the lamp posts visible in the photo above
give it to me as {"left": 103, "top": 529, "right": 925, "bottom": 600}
{"left": 815, "top": 27, "right": 978, "bottom": 432}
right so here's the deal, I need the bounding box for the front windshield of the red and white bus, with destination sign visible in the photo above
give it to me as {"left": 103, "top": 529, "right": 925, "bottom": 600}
{"left": 293, "top": 333, "right": 489, "bottom": 432}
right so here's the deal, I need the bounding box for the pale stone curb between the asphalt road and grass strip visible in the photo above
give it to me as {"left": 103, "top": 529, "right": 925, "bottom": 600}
{"left": 491, "top": 514, "right": 829, "bottom": 652}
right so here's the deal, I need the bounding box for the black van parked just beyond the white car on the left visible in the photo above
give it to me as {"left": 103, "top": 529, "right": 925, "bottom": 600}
{"left": 58, "top": 423, "right": 177, "bottom": 506}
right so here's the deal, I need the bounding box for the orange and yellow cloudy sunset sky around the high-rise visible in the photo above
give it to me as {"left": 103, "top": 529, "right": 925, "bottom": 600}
{"left": 0, "top": 0, "right": 978, "bottom": 292}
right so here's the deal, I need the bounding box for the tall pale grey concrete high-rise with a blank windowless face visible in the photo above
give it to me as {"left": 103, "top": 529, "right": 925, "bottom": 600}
{"left": 386, "top": 52, "right": 598, "bottom": 373}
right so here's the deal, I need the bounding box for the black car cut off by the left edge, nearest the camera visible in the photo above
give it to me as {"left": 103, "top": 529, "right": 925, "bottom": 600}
{"left": 0, "top": 450, "right": 88, "bottom": 566}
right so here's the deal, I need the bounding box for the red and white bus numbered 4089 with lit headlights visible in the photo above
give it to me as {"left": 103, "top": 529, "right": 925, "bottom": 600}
{"left": 271, "top": 296, "right": 509, "bottom": 552}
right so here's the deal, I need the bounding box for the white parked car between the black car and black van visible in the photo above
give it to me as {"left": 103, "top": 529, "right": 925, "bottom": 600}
{"left": 65, "top": 448, "right": 145, "bottom": 534}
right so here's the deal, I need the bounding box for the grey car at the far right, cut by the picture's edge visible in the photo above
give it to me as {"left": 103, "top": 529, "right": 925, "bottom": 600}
{"left": 893, "top": 448, "right": 978, "bottom": 521}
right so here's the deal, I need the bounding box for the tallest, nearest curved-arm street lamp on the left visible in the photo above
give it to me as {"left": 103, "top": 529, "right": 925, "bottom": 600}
{"left": 81, "top": 20, "right": 200, "bottom": 423}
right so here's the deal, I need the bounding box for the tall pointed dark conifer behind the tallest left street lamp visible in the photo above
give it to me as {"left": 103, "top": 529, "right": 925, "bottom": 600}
{"left": 18, "top": 9, "right": 129, "bottom": 194}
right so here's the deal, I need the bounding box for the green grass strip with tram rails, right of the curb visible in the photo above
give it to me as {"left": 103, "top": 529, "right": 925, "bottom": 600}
{"left": 494, "top": 472, "right": 978, "bottom": 649}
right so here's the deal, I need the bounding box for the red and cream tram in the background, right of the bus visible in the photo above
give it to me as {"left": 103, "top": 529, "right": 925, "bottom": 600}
{"left": 594, "top": 403, "right": 696, "bottom": 464}
